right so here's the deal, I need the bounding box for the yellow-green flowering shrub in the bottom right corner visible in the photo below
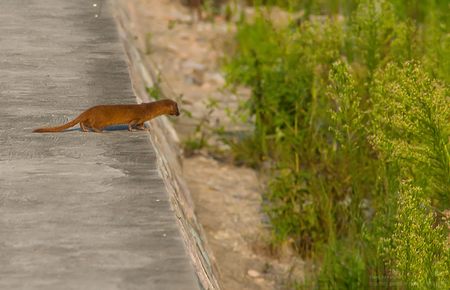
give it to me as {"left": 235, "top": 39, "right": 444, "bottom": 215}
{"left": 392, "top": 181, "right": 450, "bottom": 290}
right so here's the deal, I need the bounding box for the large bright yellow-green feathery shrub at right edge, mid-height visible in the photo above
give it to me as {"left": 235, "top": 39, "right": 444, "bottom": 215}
{"left": 373, "top": 62, "right": 450, "bottom": 208}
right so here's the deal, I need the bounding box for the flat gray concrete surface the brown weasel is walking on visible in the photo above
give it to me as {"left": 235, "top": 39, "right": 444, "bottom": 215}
{"left": 0, "top": 0, "right": 199, "bottom": 290}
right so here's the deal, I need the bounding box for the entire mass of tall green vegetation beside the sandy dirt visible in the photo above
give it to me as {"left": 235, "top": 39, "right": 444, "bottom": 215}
{"left": 225, "top": 0, "right": 450, "bottom": 289}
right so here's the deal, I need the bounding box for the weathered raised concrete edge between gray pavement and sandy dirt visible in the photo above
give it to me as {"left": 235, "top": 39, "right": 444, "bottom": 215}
{"left": 114, "top": 0, "right": 220, "bottom": 289}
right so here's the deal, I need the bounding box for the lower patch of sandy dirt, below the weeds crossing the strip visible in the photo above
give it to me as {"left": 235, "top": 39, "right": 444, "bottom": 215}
{"left": 184, "top": 156, "right": 303, "bottom": 290}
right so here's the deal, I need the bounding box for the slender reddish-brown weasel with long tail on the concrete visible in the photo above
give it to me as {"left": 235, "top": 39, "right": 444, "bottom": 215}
{"left": 33, "top": 99, "right": 180, "bottom": 133}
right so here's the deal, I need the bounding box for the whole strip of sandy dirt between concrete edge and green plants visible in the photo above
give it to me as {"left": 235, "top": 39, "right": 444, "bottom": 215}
{"left": 127, "top": 0, "right": 303, "bottom": 290}
